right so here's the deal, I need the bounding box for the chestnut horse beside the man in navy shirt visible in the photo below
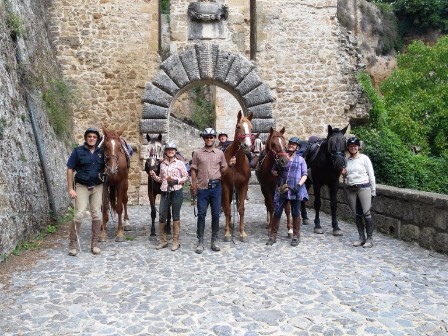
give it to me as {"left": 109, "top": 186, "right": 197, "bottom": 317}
{"left": 99, "top": 128, "right": 131, "bottom": 242}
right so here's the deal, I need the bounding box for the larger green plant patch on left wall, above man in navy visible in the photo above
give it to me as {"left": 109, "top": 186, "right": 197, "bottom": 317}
{"left": 42, "top": 78, "right": 74, "bottom": 136}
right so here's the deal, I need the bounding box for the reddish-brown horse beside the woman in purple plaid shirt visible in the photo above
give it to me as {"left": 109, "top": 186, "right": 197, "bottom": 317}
{"left": 255, "top": 127, "right": 293, "bottom": 238}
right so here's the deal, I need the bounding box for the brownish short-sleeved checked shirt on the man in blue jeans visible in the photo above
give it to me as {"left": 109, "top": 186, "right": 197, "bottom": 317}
{"left": 191, "top": 147, "right": 227, "bottom": 189}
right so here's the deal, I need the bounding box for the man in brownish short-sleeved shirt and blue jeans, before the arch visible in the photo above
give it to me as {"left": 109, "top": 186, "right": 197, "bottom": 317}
{"left": 191, "top": 127, "right": 236, "bottom": 254}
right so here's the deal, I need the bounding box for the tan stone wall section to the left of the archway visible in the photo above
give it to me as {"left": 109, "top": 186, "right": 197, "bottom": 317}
{"left": 46, "top": 0, "right": 159, "bottom": 203}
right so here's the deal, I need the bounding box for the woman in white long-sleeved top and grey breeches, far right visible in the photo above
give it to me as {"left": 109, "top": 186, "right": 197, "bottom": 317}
{"left": 342, "top": 136, "right": 376, "bottom": 248}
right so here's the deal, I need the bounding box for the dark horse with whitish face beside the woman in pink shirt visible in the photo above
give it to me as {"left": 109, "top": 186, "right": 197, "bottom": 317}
{"left": 145, "top": 134, "right": 171, "bottom": 240}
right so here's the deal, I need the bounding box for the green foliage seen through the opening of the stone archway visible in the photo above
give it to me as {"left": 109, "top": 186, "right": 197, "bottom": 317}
{"left": 191, "top": 85, "right": 215, "bottom": 130}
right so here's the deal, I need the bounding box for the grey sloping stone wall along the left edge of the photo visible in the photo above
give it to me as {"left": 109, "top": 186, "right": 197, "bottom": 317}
{"left": 0, "top": 0, "right": 70, "bottom": 255}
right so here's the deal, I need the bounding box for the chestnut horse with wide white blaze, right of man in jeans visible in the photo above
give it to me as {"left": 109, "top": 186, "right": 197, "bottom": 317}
{"left": 221, "top": 111, "right": 253, "bottom": 242}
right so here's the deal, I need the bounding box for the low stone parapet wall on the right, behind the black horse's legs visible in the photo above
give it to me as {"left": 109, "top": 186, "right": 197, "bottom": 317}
{"left": 308, "top": 185, "right": 448, "bottom": 254}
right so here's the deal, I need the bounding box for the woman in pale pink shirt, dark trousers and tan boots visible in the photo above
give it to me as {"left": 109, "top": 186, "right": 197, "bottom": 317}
{"left": 149, "top": 142, "right": 189, "bottom": 251}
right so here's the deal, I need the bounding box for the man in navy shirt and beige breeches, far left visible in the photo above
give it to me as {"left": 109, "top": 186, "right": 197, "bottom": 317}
{"left": 67, "top": 127, "right": 105, "bottom": 256}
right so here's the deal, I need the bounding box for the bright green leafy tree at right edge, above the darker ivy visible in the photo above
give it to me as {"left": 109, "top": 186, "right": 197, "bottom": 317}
{"left": 380, "top": 36, "right": 448, "bottom": 157}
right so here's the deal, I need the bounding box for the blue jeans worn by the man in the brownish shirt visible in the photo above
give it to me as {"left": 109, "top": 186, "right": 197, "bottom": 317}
{"left": 197, "top": 183, "right": 222, "bottom": 239}
